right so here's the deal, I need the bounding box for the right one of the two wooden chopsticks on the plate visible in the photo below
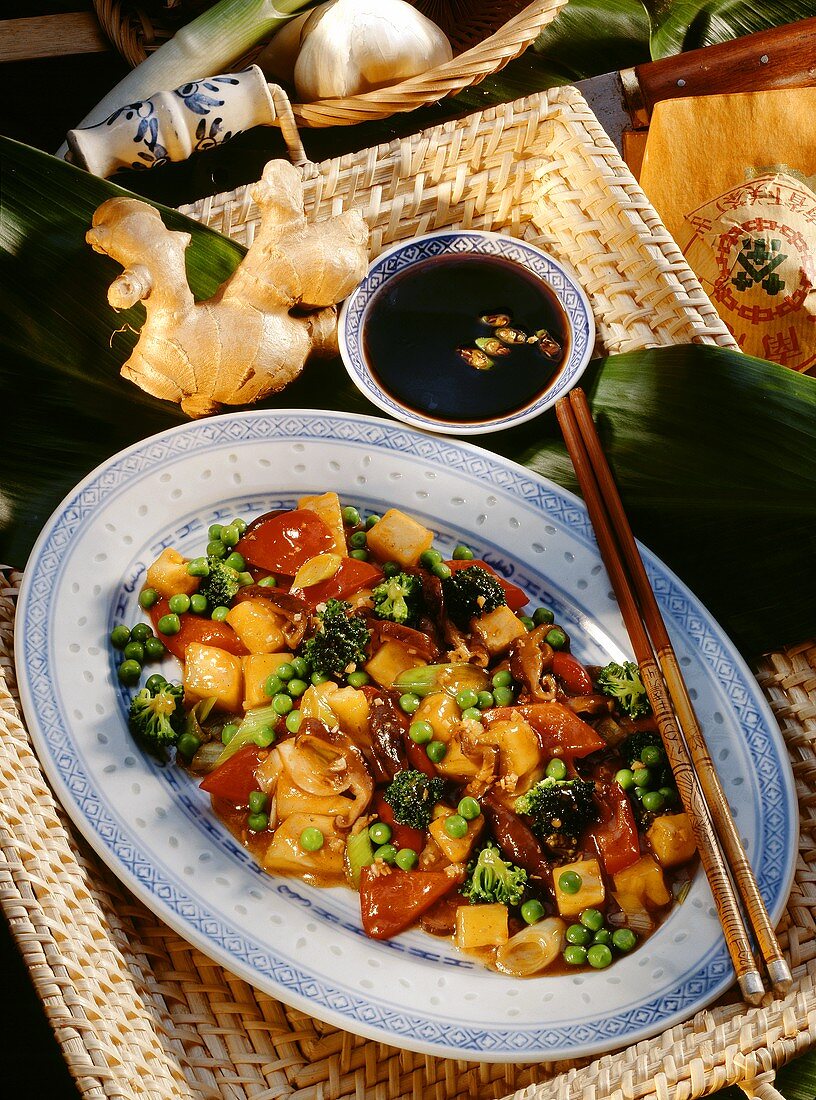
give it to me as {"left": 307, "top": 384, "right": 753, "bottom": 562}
{"left": 570, "top": 389, "right": 792, "bottom": 993}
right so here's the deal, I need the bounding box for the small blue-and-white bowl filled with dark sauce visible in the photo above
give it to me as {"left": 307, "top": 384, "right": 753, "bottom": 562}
{"left": 339, "top": 230, "right": 595, "bottom": 436}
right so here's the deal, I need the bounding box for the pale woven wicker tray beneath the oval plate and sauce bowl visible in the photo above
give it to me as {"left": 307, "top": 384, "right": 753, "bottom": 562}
{"left": 0, "top": 89, "right": 816, "bottom": 1100}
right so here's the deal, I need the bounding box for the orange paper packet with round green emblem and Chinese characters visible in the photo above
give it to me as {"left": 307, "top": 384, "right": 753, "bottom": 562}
{"left": 641, "top": 88, "right": 816, "bottom": 373}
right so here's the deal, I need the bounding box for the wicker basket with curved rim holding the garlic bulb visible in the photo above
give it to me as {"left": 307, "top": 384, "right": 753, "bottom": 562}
{"left": 93, "top": 0, "right": 566, "bottom": 127}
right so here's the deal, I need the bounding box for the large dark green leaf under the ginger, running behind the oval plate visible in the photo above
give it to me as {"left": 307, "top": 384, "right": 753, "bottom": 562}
{"left": 0, "top": 133, "right": 816, "bottom": 656}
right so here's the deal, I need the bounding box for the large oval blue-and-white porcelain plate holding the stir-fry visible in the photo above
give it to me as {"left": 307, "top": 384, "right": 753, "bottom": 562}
{"left": 15, "top": 411, "right": 797, "bottom": 1063}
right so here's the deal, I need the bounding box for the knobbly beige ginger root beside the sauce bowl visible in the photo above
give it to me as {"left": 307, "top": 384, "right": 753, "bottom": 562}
{"left": 86, "top": 161, "right": 368, "bottom": 417}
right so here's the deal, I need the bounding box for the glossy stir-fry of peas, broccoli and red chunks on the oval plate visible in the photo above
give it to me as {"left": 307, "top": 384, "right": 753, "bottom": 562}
{"left": 111, "top": 493, "right": 696, "bottom": 977}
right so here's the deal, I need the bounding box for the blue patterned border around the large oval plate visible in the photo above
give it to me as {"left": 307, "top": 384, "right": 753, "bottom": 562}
{"left": 15, "top": 410, "right": 798, "bottom": 1063}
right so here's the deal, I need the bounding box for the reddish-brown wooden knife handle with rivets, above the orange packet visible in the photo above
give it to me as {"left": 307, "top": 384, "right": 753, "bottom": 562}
{"left": 620, "top": 18, "right": 816, "bottom": 128}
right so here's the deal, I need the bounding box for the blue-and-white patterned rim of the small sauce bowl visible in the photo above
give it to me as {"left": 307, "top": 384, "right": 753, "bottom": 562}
{"left": 338, "top": 230, "right": 595, "bottom": 436}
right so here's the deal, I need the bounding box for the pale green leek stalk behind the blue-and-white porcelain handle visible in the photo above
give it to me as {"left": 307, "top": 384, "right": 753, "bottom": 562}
{"left": 57, "top": 0, "right": 310, "bottom": 158}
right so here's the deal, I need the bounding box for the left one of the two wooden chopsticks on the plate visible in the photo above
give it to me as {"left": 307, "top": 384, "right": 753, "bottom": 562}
{"left": 555, "top": 391, "right": 764, "bottom": 1004}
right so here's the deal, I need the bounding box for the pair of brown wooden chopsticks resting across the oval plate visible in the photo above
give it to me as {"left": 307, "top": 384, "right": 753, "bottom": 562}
{"left": 555, "top": 388, "right": 792, "bottom": 1004}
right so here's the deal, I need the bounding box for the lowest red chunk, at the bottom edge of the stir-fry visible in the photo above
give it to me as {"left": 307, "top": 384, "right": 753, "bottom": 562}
{"left": 360, "top": 867, "right": 460, "bottom": 939}
